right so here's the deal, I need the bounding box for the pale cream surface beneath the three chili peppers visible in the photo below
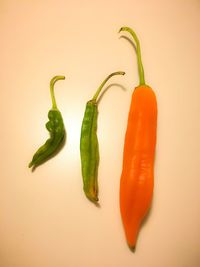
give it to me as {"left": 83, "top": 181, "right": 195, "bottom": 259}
{"left": 0, "top": 0, "right": 200, "bottom": 267}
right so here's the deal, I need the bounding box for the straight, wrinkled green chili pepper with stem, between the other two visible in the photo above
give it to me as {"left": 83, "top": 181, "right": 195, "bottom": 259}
{"left": 80, "top": 71, "right": 125, "bottom": 203}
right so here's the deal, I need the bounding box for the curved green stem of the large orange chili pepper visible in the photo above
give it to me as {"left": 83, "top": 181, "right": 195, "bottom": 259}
{"left": 119, "top": 27, "right": 145, "bottom": 85}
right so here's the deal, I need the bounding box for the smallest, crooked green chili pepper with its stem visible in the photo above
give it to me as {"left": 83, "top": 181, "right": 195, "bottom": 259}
{"left": 29, "top": 76, "right": 65, "bottom": 168}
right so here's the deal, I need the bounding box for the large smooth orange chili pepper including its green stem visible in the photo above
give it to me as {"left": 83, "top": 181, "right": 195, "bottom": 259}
{"left": 119, "top": 27, "right": 157, "bottom": 250}
